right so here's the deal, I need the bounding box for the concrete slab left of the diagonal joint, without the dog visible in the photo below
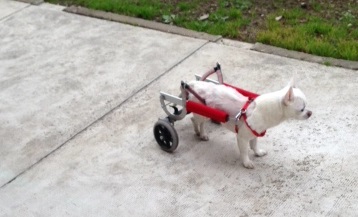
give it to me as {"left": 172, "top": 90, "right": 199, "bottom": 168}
{"left": 0, "top": 1, "right": 206, "bottom": 186}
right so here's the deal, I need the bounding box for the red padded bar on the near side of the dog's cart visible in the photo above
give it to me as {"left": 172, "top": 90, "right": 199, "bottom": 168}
{"left": 186, "top": 101, "right": 229, "bottom": 123}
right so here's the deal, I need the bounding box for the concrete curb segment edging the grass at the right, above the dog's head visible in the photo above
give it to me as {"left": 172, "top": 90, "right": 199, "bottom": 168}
{"left": 251, "top": 43, "right": 358, "bottom": 70}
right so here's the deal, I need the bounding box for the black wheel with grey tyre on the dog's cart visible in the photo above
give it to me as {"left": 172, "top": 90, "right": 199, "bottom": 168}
{"left": 153, "top": 119, "right": 179, "bottom": 152}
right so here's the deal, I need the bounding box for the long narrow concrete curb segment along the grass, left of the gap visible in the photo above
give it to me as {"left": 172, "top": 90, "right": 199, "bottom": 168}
{"left": 64, "top": 6, "right": 222, "bottom": 42}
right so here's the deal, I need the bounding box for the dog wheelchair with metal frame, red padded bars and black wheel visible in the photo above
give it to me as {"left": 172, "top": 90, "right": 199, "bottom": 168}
{"left": 153, "top": 63, "right": 259, "bottom": 152}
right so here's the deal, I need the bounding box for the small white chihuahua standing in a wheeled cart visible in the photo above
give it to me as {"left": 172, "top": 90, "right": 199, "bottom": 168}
{"left": 188, "top": 81, "right": 312, "bottom": 169}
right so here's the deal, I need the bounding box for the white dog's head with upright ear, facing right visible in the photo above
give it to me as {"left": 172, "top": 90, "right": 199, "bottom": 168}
{"left": 282, "top": 79, "right": 312, "bottom": 120}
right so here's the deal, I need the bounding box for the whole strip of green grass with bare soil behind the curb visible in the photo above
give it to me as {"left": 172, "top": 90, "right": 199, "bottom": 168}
{"left": 48, "top": 0, "right": 358, "bottom": 61}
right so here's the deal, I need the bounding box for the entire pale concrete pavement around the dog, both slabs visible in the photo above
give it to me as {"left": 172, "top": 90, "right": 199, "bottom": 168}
{"left": 0, "top": 0, "right": 358, "bottom": 216}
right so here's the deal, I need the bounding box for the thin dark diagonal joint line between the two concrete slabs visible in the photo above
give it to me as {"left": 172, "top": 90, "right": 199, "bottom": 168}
{"left": 0, "top": 41, "right": 210, "bottom": 189}
